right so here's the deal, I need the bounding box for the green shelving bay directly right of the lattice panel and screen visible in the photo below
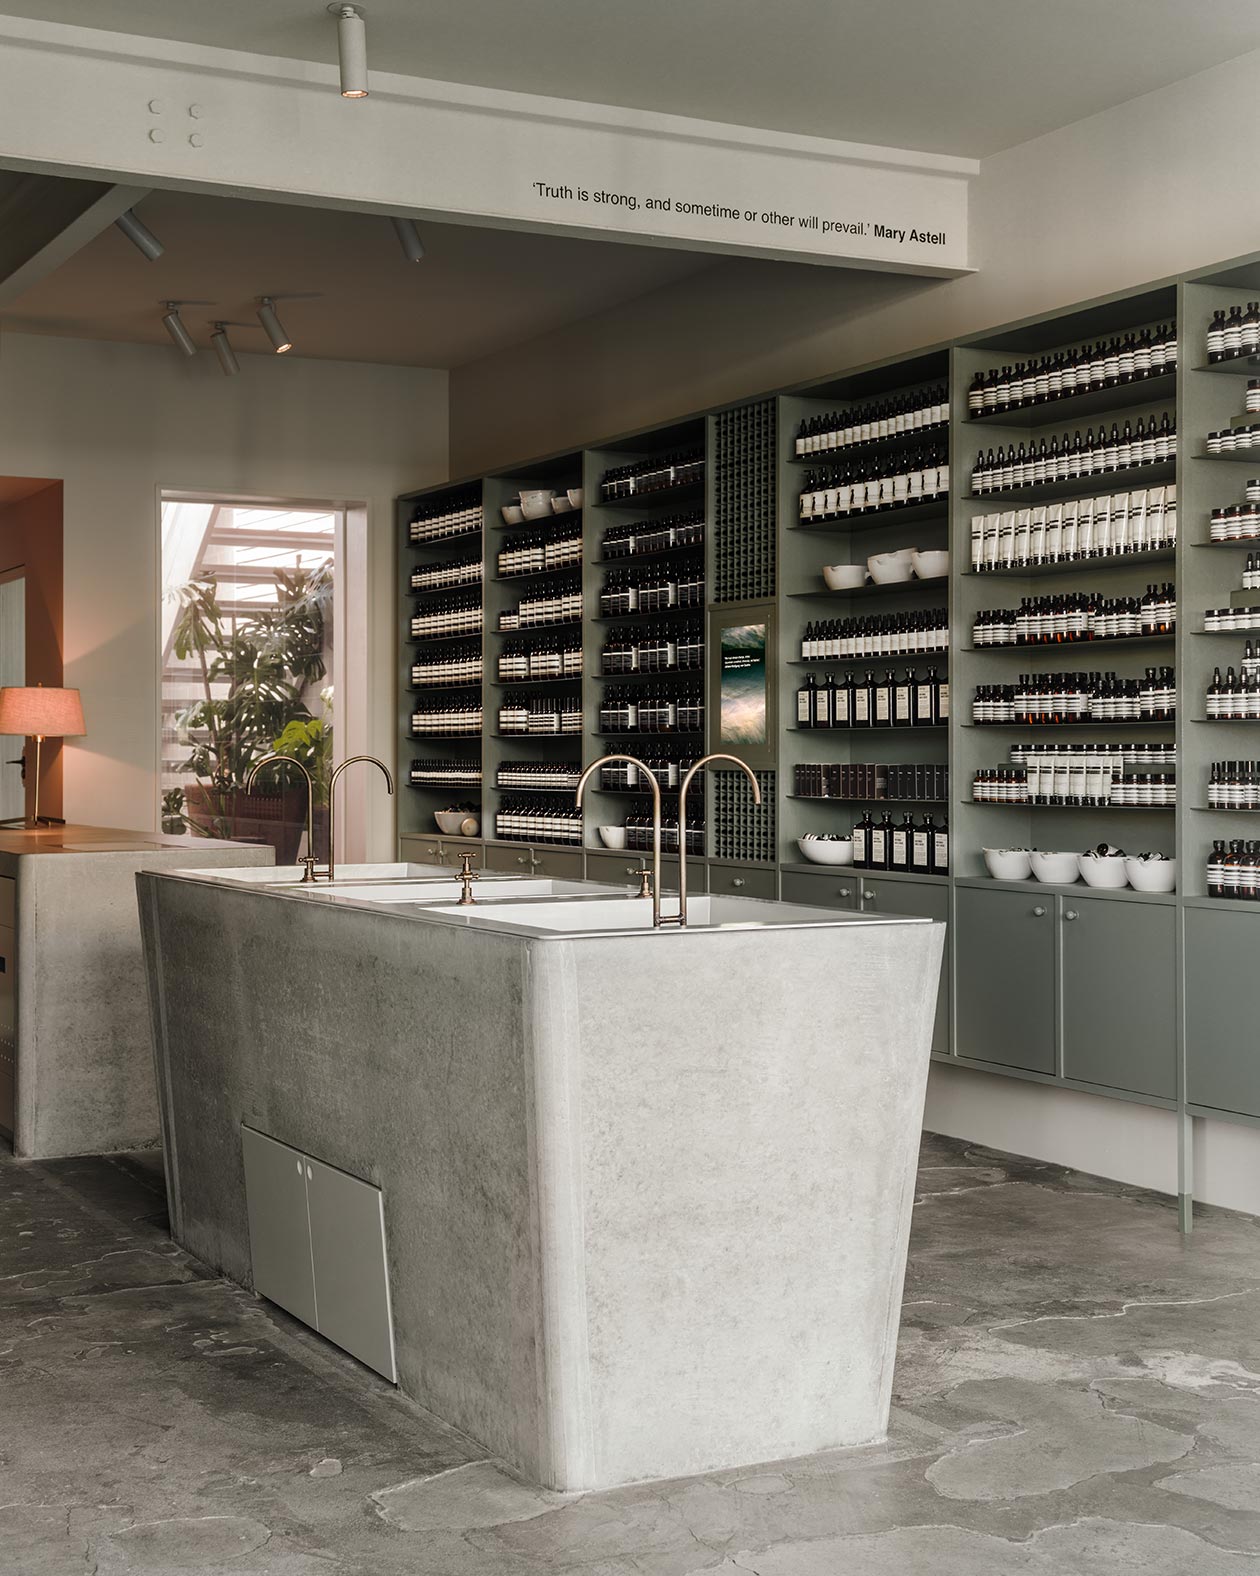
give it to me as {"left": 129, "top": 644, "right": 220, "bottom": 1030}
{"left": 777, "top": 350, "right": 954, "bottom": 883}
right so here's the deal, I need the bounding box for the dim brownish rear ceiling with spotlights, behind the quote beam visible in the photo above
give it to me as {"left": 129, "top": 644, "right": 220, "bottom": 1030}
{"left": 0, "top": 189, "right": 713, "bottom": 367}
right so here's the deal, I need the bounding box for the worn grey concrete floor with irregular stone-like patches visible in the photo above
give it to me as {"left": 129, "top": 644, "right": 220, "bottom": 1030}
{"left": 0, "top": 1138, "right": 1260, "bottom": 1576}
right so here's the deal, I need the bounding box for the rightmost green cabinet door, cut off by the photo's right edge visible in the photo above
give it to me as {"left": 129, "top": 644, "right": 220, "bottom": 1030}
{"left": 1186, "top": 905, "right": 1260, "bottom": 1116}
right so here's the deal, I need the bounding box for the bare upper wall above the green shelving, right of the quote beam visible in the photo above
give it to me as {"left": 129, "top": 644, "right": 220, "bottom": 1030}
{"left": 451, "top": 52, "right": 1260, "bottom": 473}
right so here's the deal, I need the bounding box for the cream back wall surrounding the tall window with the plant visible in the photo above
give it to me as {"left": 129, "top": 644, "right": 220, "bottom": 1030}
{"left": 0, "top": 334, "right": 448, "bottom": 859}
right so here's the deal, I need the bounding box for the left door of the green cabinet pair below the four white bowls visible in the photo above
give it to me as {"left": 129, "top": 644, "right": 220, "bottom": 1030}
{"left": 954, "top": 886, "right": 1055, "bottom": 1073}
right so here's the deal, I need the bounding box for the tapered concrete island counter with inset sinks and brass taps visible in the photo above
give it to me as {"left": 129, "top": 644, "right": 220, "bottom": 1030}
{"left": 137, "top": 865, "right": 945, "bottom": 1491}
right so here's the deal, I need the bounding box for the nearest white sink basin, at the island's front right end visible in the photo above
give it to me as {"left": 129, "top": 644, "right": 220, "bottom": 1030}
{"left": 427, "top": 883, "right": 927, "bottom": 936}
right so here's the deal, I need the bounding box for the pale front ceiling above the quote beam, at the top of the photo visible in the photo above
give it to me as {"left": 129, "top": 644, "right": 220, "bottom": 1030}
{"left": 0, "top": 0, "right": 1260, "bottom": 158}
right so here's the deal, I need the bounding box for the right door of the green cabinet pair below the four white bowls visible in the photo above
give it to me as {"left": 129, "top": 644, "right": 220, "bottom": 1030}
{"left": 1058, "top": 895, "right": 1176, "bottom": 1100}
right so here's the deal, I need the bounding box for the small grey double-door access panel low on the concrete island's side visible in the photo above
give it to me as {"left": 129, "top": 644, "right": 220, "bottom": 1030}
{"left": 241, "top": 1125, "right": 397, "bottom": 1384}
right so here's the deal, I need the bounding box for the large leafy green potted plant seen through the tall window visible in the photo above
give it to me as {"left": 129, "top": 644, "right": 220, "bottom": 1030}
{"left": 172, "top": 564, "right": 333, "bottom": 864}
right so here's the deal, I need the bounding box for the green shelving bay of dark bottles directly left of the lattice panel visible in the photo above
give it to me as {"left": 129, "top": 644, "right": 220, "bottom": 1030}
{"left": 582, "top": 418, "right": 711, "bottom": 867}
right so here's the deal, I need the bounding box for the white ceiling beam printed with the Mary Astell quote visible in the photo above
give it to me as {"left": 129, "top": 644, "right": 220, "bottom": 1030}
{"left": 0, "top": 16, "right": 979, "bottom": 277}
